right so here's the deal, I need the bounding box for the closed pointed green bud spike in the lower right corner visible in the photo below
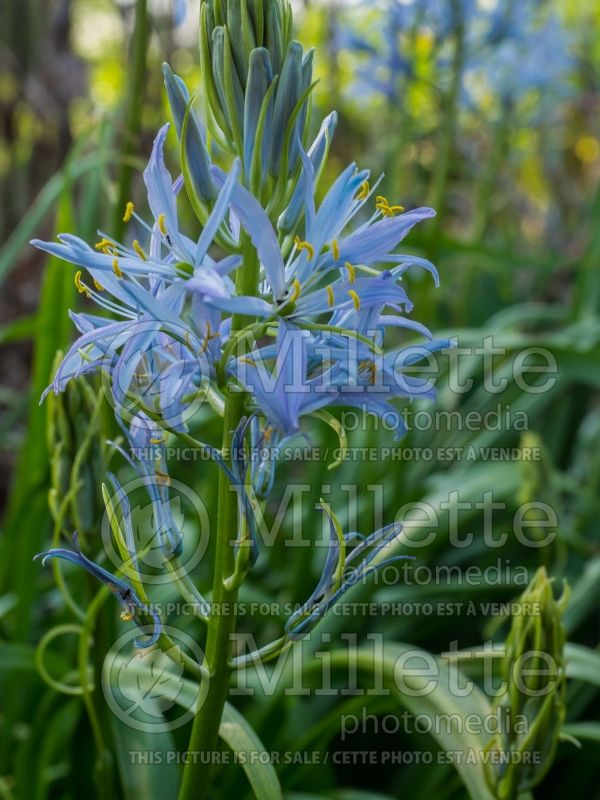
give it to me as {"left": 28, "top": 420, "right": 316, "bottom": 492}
{"left": 486, "top": 567, "right": 569, "bottom": 800}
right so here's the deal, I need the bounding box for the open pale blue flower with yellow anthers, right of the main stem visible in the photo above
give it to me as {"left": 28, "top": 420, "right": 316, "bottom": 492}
{"left": 211, "top": 154, "right": 437, "bottom": 321}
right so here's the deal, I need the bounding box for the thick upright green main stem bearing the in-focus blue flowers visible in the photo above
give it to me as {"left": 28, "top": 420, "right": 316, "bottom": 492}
{"left": 179, "top": 238, "right": 259, "bottom": 800}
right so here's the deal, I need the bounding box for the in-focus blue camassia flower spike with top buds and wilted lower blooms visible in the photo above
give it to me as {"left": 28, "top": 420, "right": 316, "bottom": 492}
{"left": 33, "top": 0, "right": 449, "bottom": 643}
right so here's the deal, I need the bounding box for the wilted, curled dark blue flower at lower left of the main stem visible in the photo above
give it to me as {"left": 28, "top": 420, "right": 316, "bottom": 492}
{"left": 34, "top": 533, "right": 162, "bottom": 648}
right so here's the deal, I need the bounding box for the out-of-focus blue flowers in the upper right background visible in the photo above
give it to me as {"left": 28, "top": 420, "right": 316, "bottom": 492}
{"left": 333, "top": 0, "right": 573, "bottom": 114}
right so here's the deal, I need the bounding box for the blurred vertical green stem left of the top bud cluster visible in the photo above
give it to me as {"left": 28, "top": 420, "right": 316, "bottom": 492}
{"left": 113, "top": 0, "right": 150, "bottom": 241}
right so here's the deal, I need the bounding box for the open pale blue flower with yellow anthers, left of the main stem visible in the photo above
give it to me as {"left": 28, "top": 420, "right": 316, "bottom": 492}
{"left": 32, "top": 126, "right": 241, "bottom": 412}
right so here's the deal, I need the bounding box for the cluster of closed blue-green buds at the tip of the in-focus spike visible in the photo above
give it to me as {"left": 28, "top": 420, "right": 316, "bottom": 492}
{"left": 200, "top": 0, "right": 312, "bottom": 190}
